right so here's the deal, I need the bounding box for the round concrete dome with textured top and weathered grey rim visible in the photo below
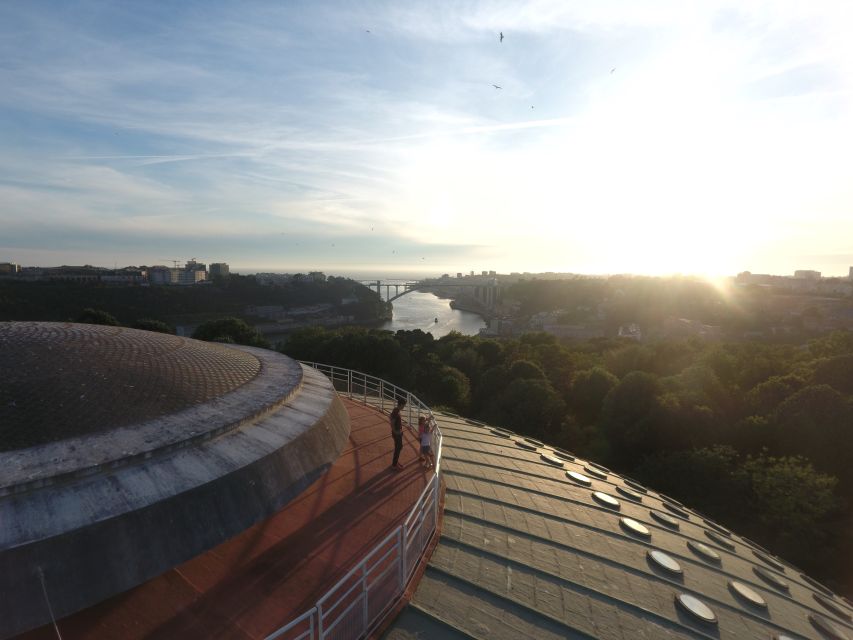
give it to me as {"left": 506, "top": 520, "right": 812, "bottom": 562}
{"left": 0, "top": 322, "right": 349, "bottom": 638}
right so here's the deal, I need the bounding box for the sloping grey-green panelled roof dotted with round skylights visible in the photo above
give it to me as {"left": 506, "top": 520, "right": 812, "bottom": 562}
{"left": 383, "top": 415, "right": 853, "bottom": 640}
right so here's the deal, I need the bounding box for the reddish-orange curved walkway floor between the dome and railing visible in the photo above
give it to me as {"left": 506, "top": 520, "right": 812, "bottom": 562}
{"left": 19, "top": 399, "right": 429, "bottom": 640}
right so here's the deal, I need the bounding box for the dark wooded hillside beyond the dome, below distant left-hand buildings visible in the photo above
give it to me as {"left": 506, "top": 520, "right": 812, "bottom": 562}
{"left": 0, "top": 274, "right": 387, "bottom": 326}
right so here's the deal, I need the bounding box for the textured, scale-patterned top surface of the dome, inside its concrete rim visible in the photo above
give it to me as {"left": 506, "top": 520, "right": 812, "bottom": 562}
{"left": 0, "top": 322, "right": 261, "bottom": 451}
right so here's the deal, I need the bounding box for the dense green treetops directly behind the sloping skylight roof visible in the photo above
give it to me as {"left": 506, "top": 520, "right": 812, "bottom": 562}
{"left": 281, "top": 328, "right": 853, "bottom": 593}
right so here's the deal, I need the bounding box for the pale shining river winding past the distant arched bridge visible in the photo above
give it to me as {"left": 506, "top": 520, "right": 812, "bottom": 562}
{"left": 381, "top": 290, "right": 486, "bottom": 338}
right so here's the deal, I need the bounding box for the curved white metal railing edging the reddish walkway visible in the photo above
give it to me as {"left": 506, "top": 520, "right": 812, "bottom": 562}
{"left": 266, "top": 362, "right": 442, "bottom": 640}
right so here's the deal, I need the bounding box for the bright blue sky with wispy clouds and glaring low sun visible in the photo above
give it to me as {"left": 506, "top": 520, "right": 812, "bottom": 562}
{"left": 0, "top": 0, "right": 853, "bottom": 277}
